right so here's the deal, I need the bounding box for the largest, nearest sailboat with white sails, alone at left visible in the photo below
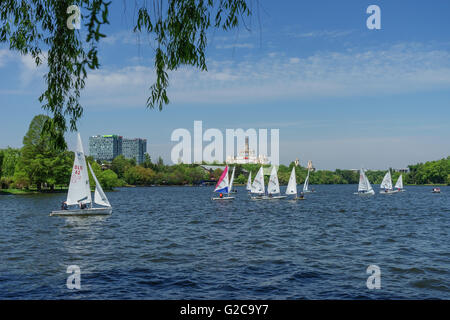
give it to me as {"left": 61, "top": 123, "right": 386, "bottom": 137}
{"left": 50, "top": 133, "right": 112, "bottom": 216}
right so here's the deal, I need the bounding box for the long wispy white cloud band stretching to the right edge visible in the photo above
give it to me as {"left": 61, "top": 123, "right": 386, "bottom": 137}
{"left": 80, "top": 40, "right": 450, "bottom": 107}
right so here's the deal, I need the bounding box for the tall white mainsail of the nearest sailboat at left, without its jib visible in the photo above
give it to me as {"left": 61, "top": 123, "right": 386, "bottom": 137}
{"left": 67, "top": 134, "right": 92, "bottom": 206}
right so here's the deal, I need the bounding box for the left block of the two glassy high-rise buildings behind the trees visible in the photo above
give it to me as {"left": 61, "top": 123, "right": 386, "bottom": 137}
{"left": 89, "top": 134, "right": 123, "bottom": 161}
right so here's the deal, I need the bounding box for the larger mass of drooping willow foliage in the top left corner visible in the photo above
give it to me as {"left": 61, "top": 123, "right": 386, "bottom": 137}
{"left": 0, "top": 0, "right": 109, "bottom": 149}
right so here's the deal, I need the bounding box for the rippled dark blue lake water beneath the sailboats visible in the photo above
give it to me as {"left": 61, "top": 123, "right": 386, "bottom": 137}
{"left": 0, "top": 185, "right": 450, "bottom": 299}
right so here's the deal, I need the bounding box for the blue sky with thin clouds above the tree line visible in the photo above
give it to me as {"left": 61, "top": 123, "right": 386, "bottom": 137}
{"left": 0, "top": 0, "right": 450, "bottom": 169}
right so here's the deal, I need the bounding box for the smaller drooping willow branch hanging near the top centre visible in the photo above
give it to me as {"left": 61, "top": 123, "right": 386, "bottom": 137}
{"left": 134, "top": 0, "right": 251, "bottom": 110}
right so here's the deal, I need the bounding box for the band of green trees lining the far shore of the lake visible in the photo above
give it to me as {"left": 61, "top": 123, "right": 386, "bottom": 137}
{"left": 0, "top": 115, "right": 450, "bottom": 194}
